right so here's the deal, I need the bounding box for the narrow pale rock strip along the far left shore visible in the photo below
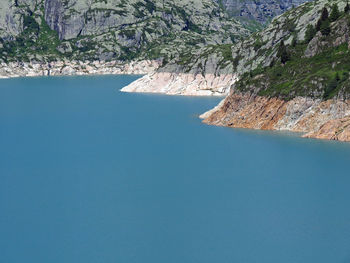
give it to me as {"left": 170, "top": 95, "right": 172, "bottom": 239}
{"left": 0, "top": 60, "right": 160, "bottom": 78}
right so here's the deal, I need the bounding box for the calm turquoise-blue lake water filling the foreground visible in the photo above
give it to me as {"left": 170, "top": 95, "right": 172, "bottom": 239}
{"left": 0, "top": 76, "right": 350, "bottom": 263}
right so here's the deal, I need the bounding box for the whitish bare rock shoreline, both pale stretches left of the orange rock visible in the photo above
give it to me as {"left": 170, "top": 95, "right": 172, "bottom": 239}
{"left": 0, "top": 60, "right": 237, "bottom": 96}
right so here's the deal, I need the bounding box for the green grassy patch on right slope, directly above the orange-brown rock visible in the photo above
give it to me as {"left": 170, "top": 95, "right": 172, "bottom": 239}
{"left": 236, "top": 41, "right": 350, "bottom": 100}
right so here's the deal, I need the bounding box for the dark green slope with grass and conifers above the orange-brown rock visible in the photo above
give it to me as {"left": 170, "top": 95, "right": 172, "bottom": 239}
{"left": 235, "top": 5, "right": 350, "bottom": 100}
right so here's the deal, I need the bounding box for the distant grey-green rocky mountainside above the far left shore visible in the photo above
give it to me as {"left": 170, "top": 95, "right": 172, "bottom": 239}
{"left": 0, "top": 0, "right": 248, "bottom": 61}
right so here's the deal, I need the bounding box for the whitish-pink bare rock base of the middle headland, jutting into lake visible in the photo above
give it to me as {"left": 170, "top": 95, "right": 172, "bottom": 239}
{"left": 121, "top": 72, "right": 237, "bottom": 96}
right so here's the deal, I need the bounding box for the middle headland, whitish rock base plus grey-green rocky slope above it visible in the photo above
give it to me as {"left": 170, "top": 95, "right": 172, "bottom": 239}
{"left": 124, "top": 1, "right": 324, "bottom": 95}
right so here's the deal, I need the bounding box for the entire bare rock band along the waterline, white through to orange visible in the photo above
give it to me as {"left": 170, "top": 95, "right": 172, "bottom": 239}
{"left": 0, "top": 60, "right": 350, "bottom": 141}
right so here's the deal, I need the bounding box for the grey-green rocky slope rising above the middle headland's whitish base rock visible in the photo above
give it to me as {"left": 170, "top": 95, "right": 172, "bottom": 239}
{"left": 164, "top": 0, "right": 346, "bottom": 75}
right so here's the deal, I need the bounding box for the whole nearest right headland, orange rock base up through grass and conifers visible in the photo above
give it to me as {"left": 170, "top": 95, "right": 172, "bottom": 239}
{"left": 203, "top": 0, "right": 350, "bottom": 141}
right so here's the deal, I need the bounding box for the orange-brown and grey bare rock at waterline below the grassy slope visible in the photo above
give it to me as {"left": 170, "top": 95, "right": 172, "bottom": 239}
{"left": 201, "top": 91, "right": 350, "bottom": 141}
